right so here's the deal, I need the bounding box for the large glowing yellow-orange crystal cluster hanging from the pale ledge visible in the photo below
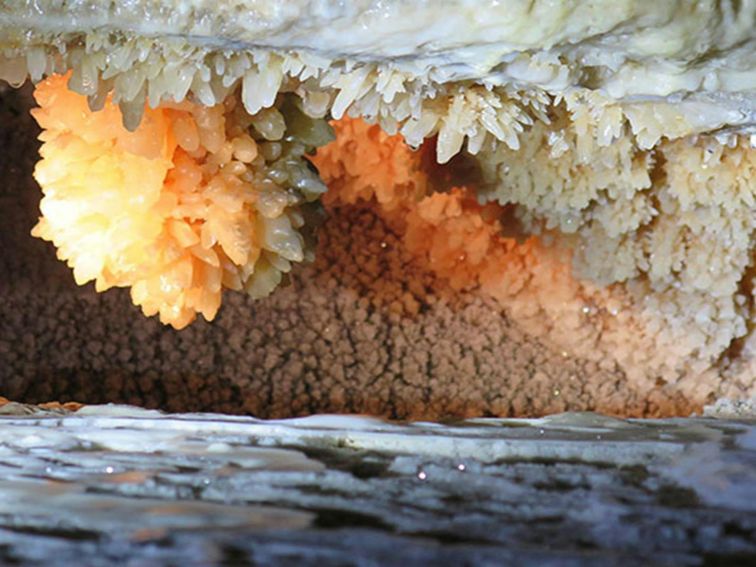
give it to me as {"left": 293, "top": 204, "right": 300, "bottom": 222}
{"left": 33, "top": 76, "right": 316, "bottom": 329}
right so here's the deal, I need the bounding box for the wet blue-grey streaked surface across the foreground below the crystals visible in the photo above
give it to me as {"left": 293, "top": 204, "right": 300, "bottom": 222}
{"left": 0, "top": 404, "right": 756, "bottom": 565}
